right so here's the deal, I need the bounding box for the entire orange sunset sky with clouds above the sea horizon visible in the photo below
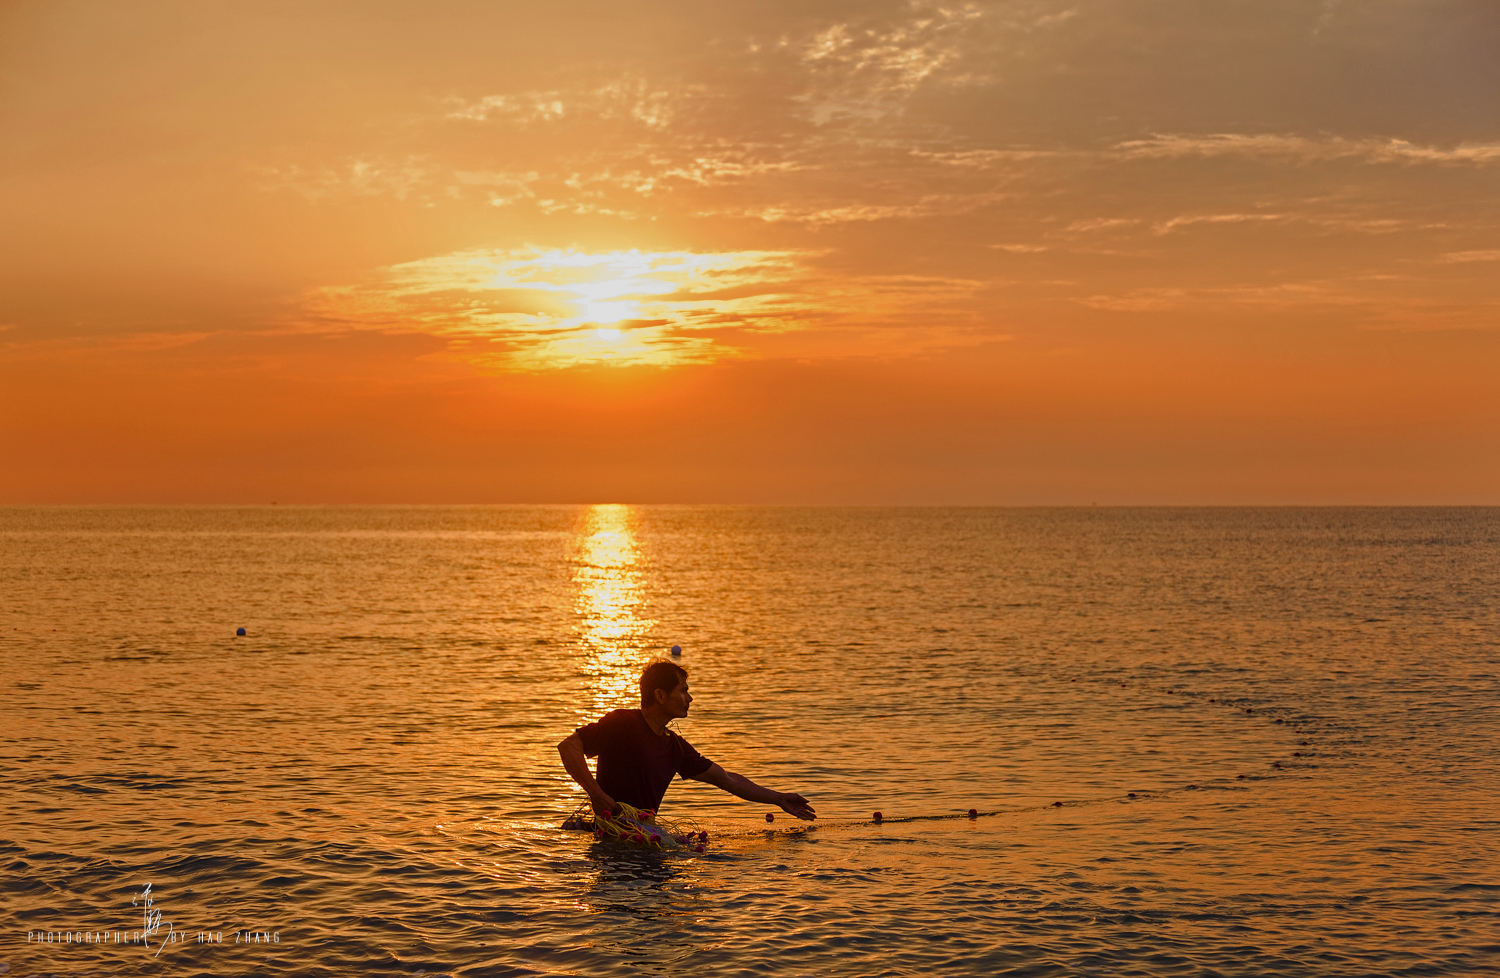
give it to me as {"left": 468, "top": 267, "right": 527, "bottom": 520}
{"left": 0, "top": 0, "right": 1500, "bottom": 504}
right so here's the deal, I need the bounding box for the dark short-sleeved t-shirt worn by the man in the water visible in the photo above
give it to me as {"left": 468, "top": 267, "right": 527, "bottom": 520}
{"left": 578, "top": 710, "right": 714, "bottom": 812}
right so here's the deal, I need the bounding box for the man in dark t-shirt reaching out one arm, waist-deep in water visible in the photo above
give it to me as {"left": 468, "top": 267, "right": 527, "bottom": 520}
{"left": 558, "top": 662, "right": 818, "bottom": 821}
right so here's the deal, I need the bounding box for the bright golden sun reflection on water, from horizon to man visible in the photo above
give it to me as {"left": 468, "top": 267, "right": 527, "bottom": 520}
{"left": 573, "top": 504, "right": 656, "bottom": 719}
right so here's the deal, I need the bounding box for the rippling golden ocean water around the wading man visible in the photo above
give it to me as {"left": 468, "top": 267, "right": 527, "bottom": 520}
{"left": 0, "top": 506, "right": 1500, "bottom": 978}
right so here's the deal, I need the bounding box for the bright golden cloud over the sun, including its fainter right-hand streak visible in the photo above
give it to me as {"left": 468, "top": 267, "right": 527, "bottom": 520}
{"left": 288, "top": 249, "right": 996, "bottom": 372}
